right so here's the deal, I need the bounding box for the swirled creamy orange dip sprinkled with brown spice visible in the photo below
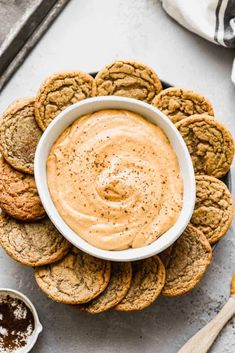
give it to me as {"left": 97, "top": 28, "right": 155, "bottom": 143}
{"left": 47, "top": 110, "right": 183, "bottom": 250}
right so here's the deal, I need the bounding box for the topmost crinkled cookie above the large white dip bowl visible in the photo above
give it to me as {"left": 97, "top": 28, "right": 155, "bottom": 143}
{"left": 95, "top": 60, "right": 162, "bottom": 103}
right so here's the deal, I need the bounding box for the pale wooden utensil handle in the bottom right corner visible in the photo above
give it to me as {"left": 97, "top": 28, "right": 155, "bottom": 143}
{"left": 177, "top": 296, "right": 235, "bottom": 353}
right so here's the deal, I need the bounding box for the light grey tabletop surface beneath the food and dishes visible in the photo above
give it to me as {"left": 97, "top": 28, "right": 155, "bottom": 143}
{"left": 0, "top": 0, "right": 235, "bottom": 353}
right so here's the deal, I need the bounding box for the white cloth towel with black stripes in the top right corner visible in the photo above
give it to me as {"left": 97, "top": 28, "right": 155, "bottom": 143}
{"left": 161, "top": 0, "right": 235, "bottom": 83}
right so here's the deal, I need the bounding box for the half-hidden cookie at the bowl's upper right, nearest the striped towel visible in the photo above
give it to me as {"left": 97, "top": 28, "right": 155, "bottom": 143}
{"left": 153, "top": 87, "right": 214, "bottom": 123}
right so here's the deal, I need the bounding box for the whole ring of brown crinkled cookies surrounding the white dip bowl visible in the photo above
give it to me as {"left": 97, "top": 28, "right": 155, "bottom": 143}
{"left": 0, "top": 61, "right": 234, "bottom": 314}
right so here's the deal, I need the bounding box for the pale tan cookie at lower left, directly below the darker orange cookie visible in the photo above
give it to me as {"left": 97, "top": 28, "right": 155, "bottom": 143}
{"left": 0, "top": 212, "right": 71, "bottom": 266}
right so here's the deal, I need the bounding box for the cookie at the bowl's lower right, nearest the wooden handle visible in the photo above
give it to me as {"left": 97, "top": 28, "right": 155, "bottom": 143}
{"left": 162, "top": 224, "right": 212, "bottom": 297}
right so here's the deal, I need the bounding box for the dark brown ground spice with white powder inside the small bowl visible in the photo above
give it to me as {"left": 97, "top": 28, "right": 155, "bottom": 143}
{"left": 0, "top": 295, "right": 35, "bottom": 353}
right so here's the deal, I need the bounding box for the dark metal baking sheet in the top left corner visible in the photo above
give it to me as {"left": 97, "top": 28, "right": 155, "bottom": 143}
{"left": 0, "top": 0, "right": 69, "bottom": 91}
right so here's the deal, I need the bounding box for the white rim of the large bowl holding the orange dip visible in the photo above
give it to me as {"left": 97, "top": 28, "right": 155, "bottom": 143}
{"left": 34, "top": 96, "right": 195, "bottom": 261}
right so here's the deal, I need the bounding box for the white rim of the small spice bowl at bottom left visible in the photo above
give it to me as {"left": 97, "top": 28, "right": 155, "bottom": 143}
{"left": 0, "top": 288, "right": 42, "bottom": 353}
